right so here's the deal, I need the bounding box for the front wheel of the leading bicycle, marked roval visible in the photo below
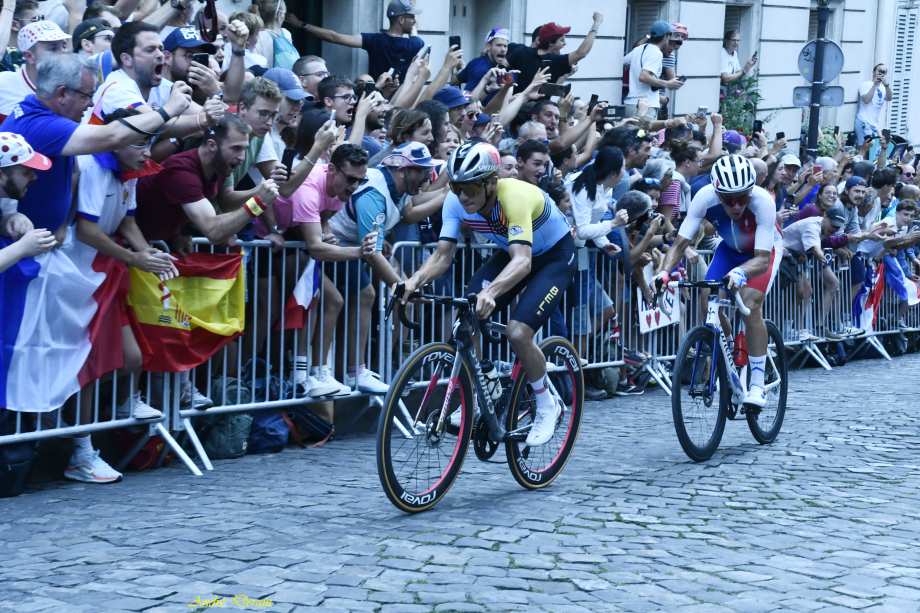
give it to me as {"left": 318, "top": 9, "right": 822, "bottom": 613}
{"left": 377, "top": 343, "right": 473, "bottom": 513}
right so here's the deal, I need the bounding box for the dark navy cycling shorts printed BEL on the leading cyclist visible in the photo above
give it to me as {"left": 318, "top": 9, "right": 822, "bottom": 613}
{"left": 466, "top": 234, "right": 578, "bottom": 331}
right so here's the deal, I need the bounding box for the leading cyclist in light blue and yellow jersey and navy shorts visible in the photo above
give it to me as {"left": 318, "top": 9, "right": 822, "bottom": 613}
{"left": 405, "top": 143, "right": 577, "bottom": 447}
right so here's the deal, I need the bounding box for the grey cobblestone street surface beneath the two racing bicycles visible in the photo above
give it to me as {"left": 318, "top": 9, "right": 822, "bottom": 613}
{"left": 0, "top": 355, "right": 920, "bottom": 613}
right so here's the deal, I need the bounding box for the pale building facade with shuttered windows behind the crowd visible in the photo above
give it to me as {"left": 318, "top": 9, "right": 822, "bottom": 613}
{"left": 218, "top": 0, "right": 920, "bottom": 142}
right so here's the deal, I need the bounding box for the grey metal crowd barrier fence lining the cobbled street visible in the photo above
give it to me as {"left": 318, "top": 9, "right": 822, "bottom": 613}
{"left": 0, "top": 239, "right": 920, "bottom": 475}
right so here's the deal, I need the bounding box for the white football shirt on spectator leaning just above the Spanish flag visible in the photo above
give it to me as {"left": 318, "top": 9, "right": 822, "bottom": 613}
{"left": 77, "top": 155, "right": 137, "bottom": 236}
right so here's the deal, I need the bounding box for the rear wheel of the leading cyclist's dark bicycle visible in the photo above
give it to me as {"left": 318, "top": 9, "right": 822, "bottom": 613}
{"left": 505, "top": 336, "right": 585, "bottom": 490}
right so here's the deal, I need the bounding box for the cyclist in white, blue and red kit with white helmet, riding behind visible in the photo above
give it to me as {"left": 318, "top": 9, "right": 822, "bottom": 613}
{"left": 652, "top": 155, "right": 783, "bottom": 407}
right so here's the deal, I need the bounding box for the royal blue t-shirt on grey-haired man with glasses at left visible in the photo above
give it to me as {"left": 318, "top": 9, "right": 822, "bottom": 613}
{"left": 0, "top": 94, "right": 80, "bottom": 232}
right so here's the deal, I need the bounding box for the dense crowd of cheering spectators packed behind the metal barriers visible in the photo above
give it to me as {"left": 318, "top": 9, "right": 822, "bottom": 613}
{"left": 0, "top": 0, "right": 920, "bottom": 483}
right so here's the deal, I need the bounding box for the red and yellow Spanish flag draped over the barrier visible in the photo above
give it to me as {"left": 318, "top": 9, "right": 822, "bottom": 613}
{"left": 128, "top": 253, "right": 246, "bottom": 372}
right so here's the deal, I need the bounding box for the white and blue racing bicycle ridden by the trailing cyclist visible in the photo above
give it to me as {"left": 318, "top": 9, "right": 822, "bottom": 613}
{"left": 656, "top": 277, "right": 789, "bottom": 462}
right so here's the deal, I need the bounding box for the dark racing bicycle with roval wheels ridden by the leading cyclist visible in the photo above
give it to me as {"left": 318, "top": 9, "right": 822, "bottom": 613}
{"left": 377, "top": 283, "right": 584, "bottom": 513}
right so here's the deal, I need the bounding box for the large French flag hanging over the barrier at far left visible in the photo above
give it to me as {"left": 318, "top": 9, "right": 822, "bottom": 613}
{"left": 0, "top": 227, "right": 130, "bottom": 412}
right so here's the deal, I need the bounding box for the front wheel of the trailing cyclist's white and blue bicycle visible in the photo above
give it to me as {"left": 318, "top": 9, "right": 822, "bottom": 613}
{"left": 671, "top": 326, "right": 731, "bottom": 462}
